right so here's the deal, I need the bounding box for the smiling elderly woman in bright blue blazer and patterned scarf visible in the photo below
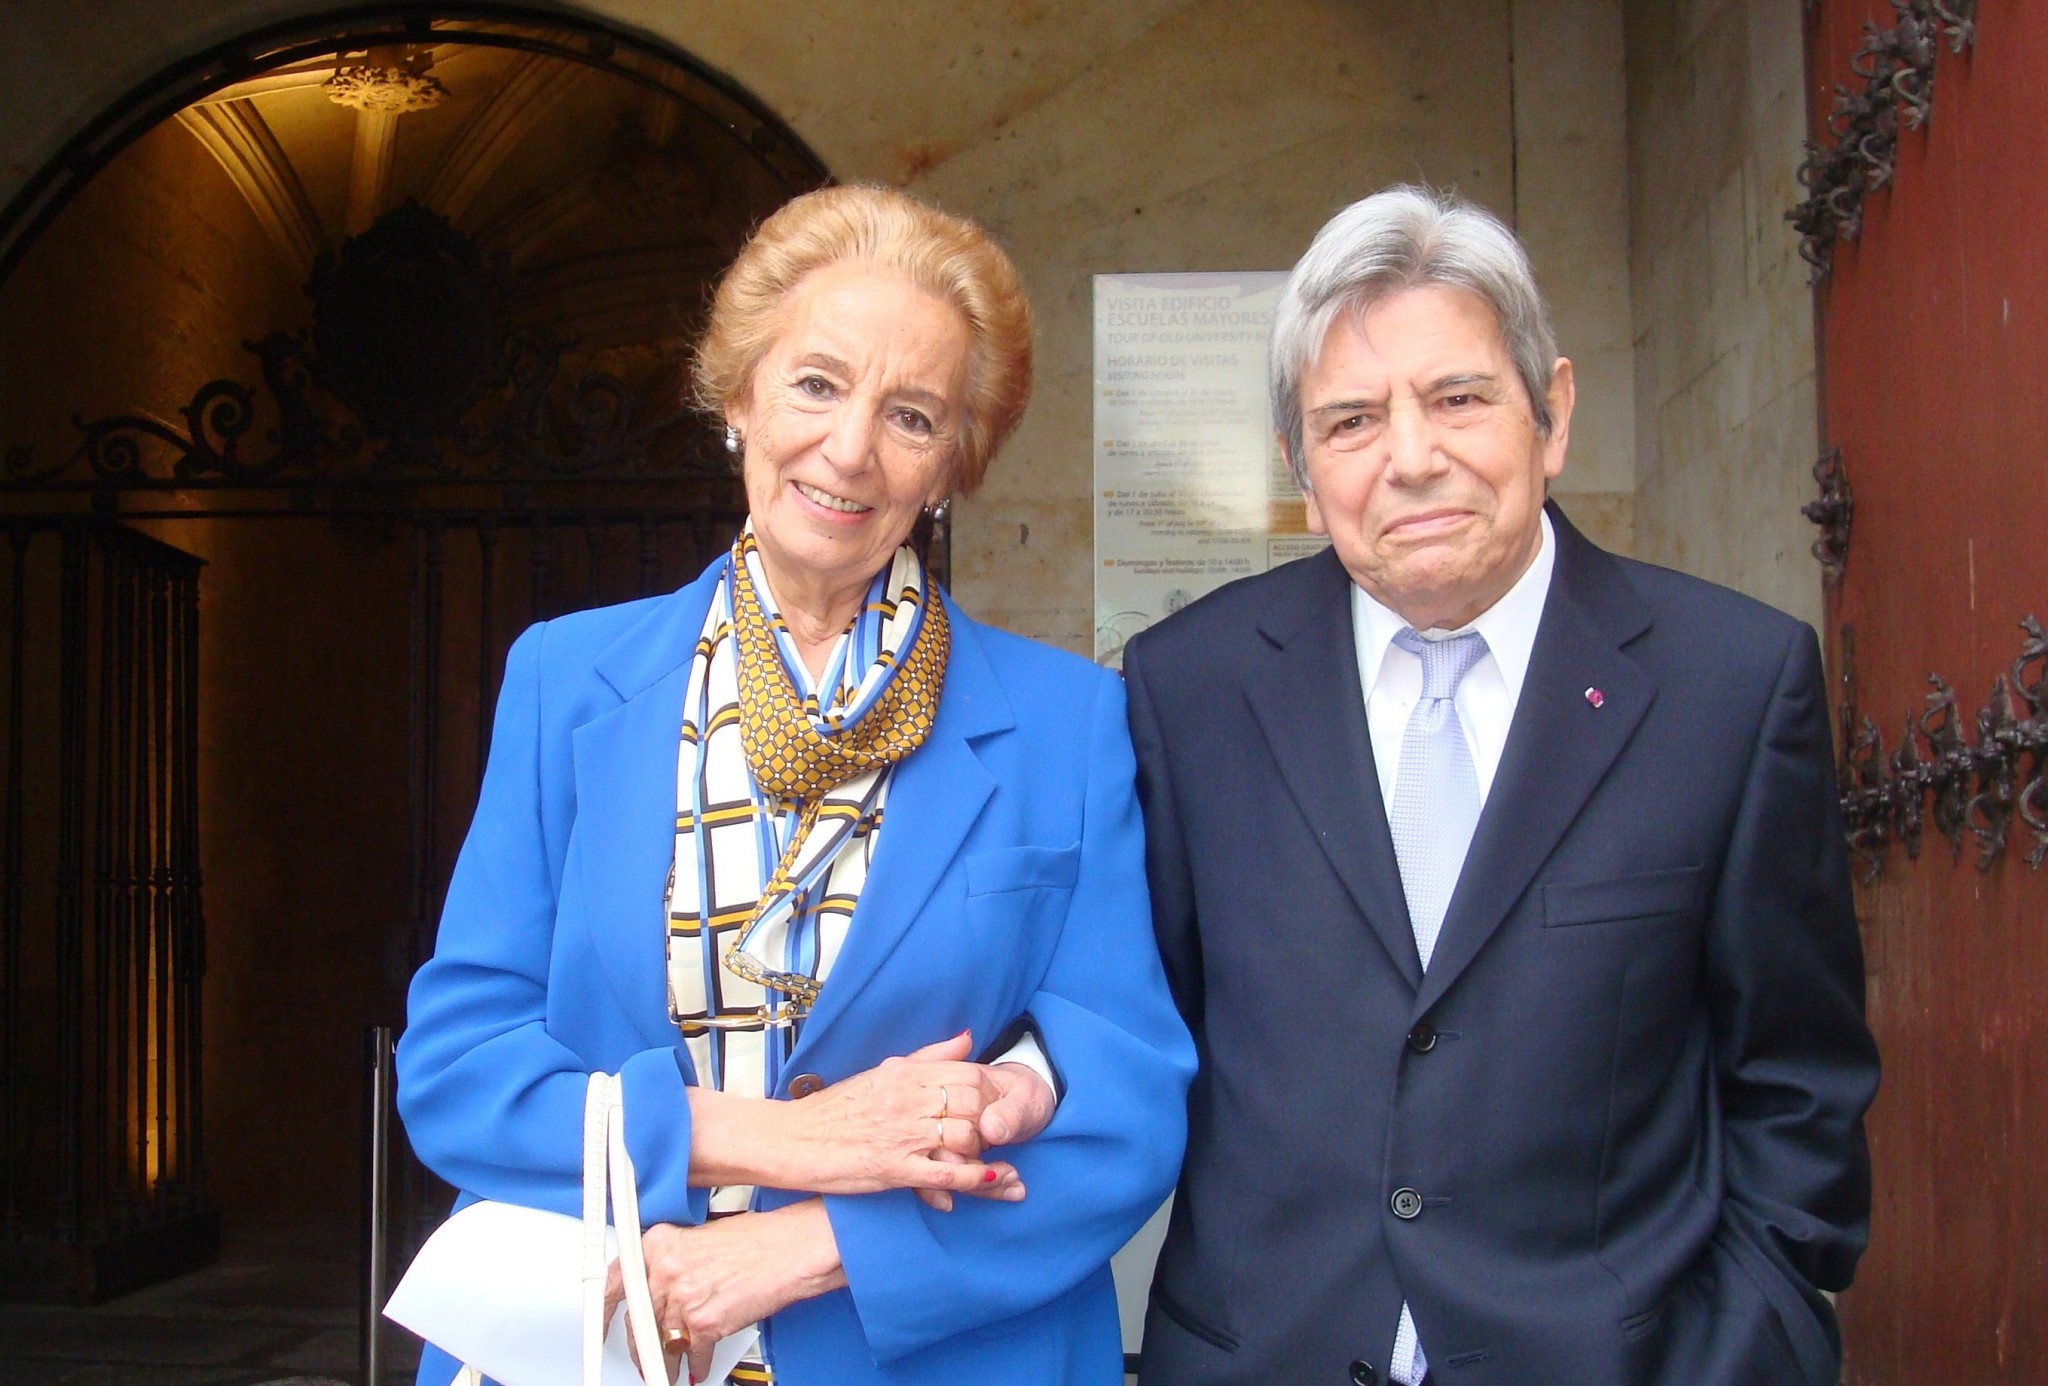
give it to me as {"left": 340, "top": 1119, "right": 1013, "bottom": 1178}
{"left": 399, "top": 188, "right": 1194, "bottom": 1386}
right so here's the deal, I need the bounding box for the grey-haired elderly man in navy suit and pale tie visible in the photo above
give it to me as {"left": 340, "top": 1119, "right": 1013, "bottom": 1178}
{"left": 1124, "top": 188, "right": 1878, "bottom": 1386}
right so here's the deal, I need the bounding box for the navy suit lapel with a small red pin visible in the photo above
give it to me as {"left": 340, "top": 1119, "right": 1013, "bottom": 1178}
{"left": 1415, "top": 508, "right": 1657, "bottom": 1015}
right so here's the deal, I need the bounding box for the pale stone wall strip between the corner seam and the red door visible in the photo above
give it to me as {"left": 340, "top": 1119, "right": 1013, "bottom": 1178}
{"left": 1626, "top": 0, "right": 1821, "bottom": 624}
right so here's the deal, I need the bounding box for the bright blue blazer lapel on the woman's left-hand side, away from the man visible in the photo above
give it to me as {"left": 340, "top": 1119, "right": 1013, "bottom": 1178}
{"left": 571, "top": 565, "right": 733, "bottom": 1048}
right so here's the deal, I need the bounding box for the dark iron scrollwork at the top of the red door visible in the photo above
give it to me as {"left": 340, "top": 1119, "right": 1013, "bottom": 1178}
{"left": 1786, "top": 0, "right": 1976, "bottom": 285}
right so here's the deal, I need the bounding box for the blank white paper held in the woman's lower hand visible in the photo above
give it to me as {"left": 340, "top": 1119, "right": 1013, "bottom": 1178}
{"left": 385, "top": 1202, "right": 760, "bottom": 1386}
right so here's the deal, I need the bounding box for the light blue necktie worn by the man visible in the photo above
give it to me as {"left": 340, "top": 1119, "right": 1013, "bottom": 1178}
{"left": 1386, "top": 629, "right": 1487, "bottom": 1386}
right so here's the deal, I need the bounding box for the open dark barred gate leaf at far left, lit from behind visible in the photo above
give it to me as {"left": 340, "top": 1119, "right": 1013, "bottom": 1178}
{"left": 0, "top": 520, "right": 219, "bottom": 1300}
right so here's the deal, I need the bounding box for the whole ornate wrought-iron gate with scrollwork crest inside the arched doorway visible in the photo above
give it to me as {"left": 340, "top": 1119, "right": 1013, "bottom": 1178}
{"left": 0, "top": 194, "right": 743, "bottom": 1300}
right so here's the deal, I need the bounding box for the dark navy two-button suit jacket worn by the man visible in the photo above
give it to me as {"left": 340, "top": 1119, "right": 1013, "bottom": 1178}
{"left": 1124, "top": 506, "right": 1878, "bottom": 1386}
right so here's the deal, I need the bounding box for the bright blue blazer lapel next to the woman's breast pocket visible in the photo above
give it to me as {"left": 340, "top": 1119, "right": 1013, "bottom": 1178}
{"left": 791, "top": 598, "right": 1016, "bottom": 1067}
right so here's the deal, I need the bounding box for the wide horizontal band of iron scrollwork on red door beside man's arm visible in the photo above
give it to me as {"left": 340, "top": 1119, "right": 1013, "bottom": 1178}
{"left": 1837, "top": 616, "right": 2048, "bottom": 882}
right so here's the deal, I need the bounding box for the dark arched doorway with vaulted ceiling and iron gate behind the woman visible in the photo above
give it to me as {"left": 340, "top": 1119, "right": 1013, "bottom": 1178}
{"left": 0, "top": 6, "right": 825, "bottom": 1300}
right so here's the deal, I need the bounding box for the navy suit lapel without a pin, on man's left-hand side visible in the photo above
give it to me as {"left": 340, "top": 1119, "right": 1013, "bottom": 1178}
{"left": 1245, "top": 551, "right": 1421, "bottom": 987}
